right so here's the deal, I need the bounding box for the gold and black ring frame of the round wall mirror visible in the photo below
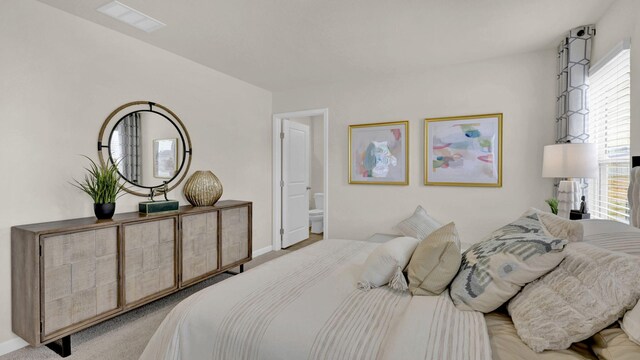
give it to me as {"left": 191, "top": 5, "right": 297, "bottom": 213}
{"left": 98, "top": 101, "right": 193, "bottom": 197}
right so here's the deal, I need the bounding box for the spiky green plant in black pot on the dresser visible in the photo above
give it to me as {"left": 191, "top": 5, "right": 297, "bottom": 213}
{"left": 71, "top": 155, "right": 124, "bottom": 219}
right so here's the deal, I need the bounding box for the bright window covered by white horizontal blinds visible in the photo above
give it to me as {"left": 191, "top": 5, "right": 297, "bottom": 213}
{"left": 588, "top": 45, "right": 631, "bottom": 223}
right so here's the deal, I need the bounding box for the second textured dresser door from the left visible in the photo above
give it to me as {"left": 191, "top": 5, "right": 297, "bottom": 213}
{"left": 123, "top": 217, "right": 177, "bottom": 305}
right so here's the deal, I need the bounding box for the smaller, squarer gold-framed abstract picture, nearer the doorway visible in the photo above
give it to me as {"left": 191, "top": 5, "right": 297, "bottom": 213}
{"left": 349, "top": 120, "right": 409, "bottom": 185}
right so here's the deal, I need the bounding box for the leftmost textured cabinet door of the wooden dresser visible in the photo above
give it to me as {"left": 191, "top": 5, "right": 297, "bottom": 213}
{"left": 41, "top": 226, "right": 118, "bottom": 339}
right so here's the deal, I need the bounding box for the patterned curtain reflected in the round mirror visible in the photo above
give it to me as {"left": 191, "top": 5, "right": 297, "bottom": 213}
{"left": 117, "top": 113, "right": 142, "bottom": 184}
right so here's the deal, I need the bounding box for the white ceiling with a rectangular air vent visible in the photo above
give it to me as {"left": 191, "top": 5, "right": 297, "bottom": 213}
{"left": 39, "top": 0, "right": 615, "bottom": 91}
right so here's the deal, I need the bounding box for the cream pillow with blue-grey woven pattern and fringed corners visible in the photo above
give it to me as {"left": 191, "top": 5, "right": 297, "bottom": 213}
{"left": 450, "top": 213, "right": 568, "bottom": 313}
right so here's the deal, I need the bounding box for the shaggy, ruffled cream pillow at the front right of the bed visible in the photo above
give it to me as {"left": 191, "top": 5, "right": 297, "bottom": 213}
{"left": 508, "top": 242, "right": 640, "bottom": 352}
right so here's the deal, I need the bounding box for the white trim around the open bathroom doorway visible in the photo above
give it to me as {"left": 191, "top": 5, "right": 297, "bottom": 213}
{"left": 271, "top": 108, "right": 329, "bottom": 251}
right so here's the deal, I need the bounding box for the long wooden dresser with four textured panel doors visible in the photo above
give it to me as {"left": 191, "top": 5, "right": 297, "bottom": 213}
{"left": 11, "top": 200, "right": 252, "bottom": 352}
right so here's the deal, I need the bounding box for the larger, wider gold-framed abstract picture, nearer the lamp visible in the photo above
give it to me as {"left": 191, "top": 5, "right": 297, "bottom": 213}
{"left": 424, "top": 113, "right": 502, "bottom": 187}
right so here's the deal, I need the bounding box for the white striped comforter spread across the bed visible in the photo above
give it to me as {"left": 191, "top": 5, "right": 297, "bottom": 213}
{"left": 141, "top": 240, "right": 491, "bottom": 360}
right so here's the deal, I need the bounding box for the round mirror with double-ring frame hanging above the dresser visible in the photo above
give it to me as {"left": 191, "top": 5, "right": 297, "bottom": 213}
{"left": 98, "top": 101, "right": 192, "bottom": 196}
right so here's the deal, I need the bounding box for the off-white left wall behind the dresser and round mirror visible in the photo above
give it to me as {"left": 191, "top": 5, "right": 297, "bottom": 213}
{"left": 0, "top": 0, "right": 272, "bottom": 345}
